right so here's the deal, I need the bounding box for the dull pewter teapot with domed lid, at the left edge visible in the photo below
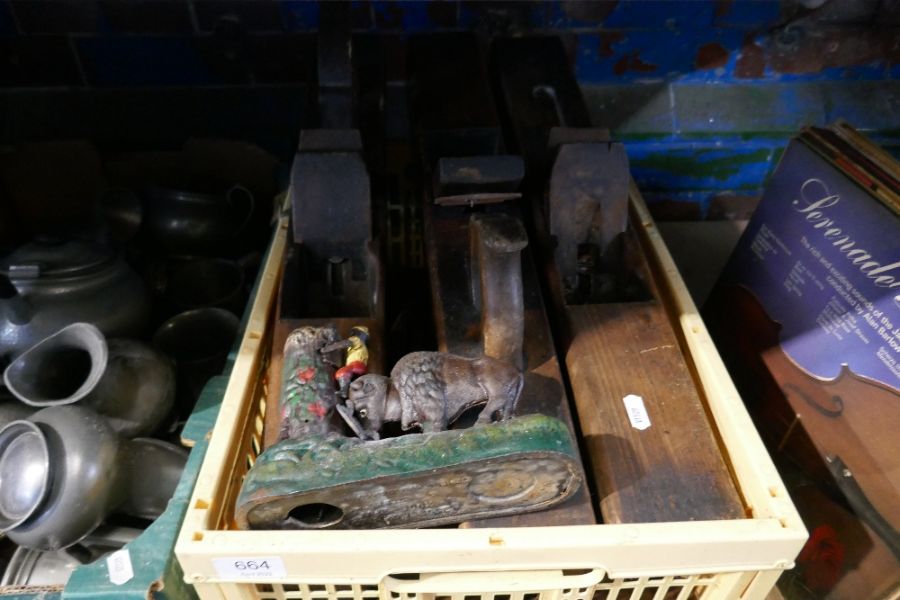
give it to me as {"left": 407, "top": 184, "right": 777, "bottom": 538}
{"left": 0, "top": 239, "right": 150, "bottom": 360}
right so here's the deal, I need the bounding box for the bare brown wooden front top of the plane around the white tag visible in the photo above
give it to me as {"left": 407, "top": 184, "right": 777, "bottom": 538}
{"left": 566, "top": 301, "right": 745, "bottom": 523}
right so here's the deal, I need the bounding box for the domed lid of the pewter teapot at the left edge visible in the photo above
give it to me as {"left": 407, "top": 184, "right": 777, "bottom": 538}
{"left": 0, "top": 239, "right": 115, "bottom": 281}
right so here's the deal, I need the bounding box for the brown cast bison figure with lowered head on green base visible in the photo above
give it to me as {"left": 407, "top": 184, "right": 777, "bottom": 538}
{"left": 347, "top": 352, "right": 523, "bottom": 439}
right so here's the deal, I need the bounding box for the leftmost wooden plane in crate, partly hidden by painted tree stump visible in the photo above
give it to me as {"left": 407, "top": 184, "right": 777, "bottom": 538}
{"left": 263, "top": 130, "right": 384, "bottom": 448}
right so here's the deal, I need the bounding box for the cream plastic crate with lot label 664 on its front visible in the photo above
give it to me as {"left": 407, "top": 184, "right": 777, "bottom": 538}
{"left": 175, "top": 185, "right": 807, "bottom": 600}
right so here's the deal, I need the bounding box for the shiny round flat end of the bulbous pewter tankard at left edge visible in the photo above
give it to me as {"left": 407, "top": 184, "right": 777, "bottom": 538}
{"left": 0, "top": 421, "right": 50, "bottom": 531}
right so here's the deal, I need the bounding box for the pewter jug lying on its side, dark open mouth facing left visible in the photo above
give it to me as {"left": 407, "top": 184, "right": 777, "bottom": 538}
{"left": 3, "top": 323, "right": 175, "bottom": 437}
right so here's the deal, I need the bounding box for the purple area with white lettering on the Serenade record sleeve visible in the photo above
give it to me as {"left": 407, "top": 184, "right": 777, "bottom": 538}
{"left": 724, "top": 141, "right": 900, "bottom": 390}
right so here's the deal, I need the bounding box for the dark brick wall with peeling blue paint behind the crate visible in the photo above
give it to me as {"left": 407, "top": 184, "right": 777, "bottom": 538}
{"left": 0, "top": 0, "right": 900, "bottom": 218}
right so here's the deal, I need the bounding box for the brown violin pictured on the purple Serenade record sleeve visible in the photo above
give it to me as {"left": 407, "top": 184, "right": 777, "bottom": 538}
{"left": 706, "top": 285, "right": 900, "bottom": 557}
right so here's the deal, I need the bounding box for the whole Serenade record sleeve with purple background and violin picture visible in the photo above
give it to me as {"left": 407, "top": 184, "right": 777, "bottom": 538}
{"left": 704, "top": 140, "right": 900, "bottom": 564}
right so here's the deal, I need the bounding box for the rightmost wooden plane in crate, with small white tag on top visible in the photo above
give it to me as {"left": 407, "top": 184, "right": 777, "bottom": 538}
{"left": 491, "top": 37, "right": 746, "bottom": 523}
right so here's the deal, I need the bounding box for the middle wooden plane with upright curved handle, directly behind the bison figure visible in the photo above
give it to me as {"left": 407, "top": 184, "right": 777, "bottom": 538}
{"left": 408, "top": 33, "right": 596, "bottom": 527}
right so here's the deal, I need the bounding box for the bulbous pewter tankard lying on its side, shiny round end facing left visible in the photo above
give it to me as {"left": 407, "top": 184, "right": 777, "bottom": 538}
{"left": 0, "top": 405, "right": 187, "bottom": 550}
